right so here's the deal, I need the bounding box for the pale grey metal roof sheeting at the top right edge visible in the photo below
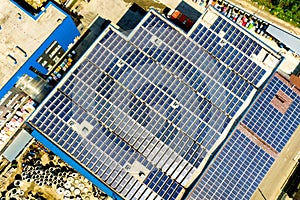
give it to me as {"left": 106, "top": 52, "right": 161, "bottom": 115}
{"left": 266, "top": 25, "right": 300, "bottom": 54}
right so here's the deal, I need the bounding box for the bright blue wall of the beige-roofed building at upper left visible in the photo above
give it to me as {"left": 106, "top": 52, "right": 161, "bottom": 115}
{"left": 0, "top": 0, "right": 80, "bottom": 99}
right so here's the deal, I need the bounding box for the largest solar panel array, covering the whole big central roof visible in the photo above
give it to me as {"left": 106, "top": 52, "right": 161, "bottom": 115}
{"left": 30, "top": 10, "right": 276, "bottom": 199}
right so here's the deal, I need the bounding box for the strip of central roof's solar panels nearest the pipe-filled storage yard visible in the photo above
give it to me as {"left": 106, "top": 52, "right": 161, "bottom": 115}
{"left": 32, "top": 91, "right": 182, "bottom": 199}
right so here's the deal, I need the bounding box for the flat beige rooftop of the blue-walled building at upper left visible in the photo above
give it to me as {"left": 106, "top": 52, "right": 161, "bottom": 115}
{"left": 0, "top": 1, "right": 66, "bottom": 89}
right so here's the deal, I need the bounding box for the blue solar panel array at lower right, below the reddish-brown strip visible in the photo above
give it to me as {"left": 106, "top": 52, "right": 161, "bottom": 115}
{"left": 188, "top": 130, "right": 274, "bottom": 199}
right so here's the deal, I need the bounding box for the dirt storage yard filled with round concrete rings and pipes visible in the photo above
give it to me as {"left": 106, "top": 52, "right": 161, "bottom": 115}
{"left": 0, "top": 141, "right": 109, "bottom": 200}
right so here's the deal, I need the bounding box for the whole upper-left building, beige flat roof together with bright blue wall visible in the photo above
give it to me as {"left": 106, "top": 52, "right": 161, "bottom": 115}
{"left": 0, "top": 1, "right": 79, "bottom": 98}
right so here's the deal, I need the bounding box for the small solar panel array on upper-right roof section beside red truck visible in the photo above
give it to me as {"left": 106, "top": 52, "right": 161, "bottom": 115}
{"left": 191, "top": 16, "right": 266, "bottom": 86}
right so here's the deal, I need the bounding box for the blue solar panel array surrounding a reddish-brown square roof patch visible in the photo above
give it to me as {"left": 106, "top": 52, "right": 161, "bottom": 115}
{"left": 243, "top": 77, "right": 300, "bottom": 152}
